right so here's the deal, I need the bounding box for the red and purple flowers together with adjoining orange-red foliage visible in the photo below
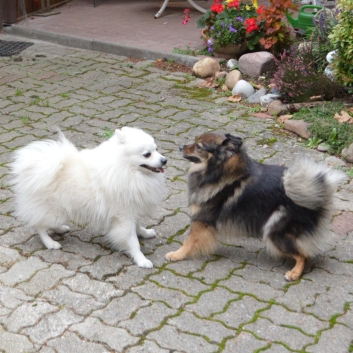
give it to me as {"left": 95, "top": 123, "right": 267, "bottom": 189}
{"left": 197, "top": 0, "right": 297, "bottom": 54}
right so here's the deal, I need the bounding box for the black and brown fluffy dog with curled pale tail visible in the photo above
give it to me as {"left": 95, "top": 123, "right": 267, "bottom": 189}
{"left": 166, "top": 133, "right": 345, "bottom": 281}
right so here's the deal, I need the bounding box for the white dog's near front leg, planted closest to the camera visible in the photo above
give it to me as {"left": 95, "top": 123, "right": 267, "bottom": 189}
{"left": 106, "top": 220, "right": 153, "bottom": 268}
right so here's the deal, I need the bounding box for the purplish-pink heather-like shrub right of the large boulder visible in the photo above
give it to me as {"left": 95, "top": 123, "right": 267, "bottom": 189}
{"left": 272, "top": 43, "right": 341, "bottom": 103}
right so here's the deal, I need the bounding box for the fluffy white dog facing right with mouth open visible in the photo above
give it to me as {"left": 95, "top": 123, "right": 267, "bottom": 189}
{"left": 11, "top": 127, "right": 167, "bottom": 268}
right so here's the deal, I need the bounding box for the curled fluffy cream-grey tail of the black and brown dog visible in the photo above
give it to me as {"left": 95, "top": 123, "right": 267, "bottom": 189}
{"left": 283, "top": 158, "right": 346, "bottom": 210}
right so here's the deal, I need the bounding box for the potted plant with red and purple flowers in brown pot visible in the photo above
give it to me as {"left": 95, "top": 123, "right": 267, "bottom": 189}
{"left": 197, "top": 0, "right": 264, "bottom": 58}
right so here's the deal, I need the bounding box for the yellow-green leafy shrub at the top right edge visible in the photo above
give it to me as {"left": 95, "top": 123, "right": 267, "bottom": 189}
{"left": 329, "top": 0, "right": 353, "bottom": 91}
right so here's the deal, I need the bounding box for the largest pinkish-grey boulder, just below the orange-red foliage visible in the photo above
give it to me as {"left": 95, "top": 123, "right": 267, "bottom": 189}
{"left": 239, "top": 51, "right": 276, "bottom": 77}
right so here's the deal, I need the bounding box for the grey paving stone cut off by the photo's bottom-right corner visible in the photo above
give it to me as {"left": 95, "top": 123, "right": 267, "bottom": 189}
{"left": 306, "top": 325, "right": 353, "bottom": 353}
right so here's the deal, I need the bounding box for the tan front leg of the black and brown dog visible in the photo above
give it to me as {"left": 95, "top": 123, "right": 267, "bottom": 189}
{"left": 165, "top": 222, "right": 217, "bottom": 261}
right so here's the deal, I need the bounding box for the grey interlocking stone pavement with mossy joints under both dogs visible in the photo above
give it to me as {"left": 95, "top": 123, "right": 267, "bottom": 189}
{"left": 0, "top": 36, "right": 353, "bottom": 353}
